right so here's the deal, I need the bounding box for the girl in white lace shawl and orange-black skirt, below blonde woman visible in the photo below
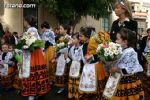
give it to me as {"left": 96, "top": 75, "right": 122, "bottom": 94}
{"left": 103, "top": 28, "right": 144, "bottom": 100}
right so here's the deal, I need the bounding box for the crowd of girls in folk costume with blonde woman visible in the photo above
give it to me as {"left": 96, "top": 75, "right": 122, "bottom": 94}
{"left": 0, "top": 2, "right": 150, "bottom": 100}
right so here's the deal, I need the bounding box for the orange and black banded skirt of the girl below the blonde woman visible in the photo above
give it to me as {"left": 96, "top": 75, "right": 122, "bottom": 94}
{"left": 102, "top": 74, "right": 144, "bottom": 100}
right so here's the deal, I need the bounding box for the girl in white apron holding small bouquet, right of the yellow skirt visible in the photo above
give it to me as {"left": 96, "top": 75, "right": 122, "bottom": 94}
{"left": 55, "top": 25, "right": 71, "bottom": 93}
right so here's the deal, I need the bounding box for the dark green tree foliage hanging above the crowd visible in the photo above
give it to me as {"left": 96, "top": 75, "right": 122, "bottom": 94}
{"left": 33, "top": 0, "right": 116, "bottom": 26}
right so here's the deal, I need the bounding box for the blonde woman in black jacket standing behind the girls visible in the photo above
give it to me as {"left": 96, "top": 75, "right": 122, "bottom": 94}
{"left": 110, "top": 0, "right": 138, "bottom": 46}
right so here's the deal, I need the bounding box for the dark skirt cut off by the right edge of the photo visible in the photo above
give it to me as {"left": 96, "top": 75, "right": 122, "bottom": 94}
{"left": 143, "top": 63, "right": 150, "bottom": 95}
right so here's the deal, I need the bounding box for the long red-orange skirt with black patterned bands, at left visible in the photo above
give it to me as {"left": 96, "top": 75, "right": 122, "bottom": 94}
{"left": 21, "top": 49, "right": 50, "bottom": 96}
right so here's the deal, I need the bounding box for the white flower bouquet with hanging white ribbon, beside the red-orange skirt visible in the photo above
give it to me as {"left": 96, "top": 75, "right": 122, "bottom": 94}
{"left": 15, "top": 32, "right": 45, "bottom": 78}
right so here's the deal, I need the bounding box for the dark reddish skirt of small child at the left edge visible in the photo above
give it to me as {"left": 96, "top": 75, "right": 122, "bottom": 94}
{"left": 1, "top": 66, "right": 15, "bottom": 89}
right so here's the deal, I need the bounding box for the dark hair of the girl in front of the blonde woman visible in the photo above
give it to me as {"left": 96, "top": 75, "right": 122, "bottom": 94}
{"left": 118, "top": 28, "right": 136, "bottom": 48}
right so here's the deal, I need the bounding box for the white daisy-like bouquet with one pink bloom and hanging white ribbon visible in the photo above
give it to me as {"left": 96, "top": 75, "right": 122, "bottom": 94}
{"left": 97, "top": 42, "right": 122, "bottom": 99}
